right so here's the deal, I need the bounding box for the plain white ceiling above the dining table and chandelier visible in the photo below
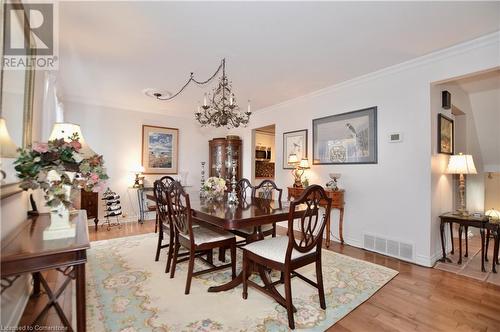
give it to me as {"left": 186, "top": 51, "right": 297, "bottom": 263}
{"left": 58, "top": 1, "right": 500, "bottom": 117}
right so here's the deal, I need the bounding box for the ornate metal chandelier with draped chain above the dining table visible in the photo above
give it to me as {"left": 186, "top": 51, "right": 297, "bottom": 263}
{"left": 148, "top": 59, "right": 252, "bottom": 129}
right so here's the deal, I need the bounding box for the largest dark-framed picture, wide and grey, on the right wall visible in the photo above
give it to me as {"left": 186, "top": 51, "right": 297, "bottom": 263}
{"left": 313, "top": 107, "right": 377, "bottom": 165}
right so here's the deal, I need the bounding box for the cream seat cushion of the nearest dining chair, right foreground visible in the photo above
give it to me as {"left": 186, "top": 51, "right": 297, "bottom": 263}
{"left": 243, "top": 236, "right": 316, "bottom": 263}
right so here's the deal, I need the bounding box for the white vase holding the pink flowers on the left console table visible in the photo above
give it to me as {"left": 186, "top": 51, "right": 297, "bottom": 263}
{"left": 43, "top": 185, "right": 76, "bottom": 240}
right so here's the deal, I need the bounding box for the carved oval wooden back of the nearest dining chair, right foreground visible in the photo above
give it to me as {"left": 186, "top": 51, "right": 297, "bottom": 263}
{"left": 285, "top": 185, "right": 332, "bottom": 262}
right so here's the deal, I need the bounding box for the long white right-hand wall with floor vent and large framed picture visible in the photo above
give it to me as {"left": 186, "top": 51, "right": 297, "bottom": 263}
{"left": 233, "top": 34, "right": 500, "bottom": 266}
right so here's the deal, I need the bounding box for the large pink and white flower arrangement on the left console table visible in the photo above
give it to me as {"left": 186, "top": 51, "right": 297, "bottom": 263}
{"left": 14, "top": 134, "right": 108, "bottom": 208}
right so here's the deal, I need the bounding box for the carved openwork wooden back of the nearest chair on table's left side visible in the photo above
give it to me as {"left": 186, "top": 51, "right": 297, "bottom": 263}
{"left": 167, "top": 181, "right": 194, "bottom": 245}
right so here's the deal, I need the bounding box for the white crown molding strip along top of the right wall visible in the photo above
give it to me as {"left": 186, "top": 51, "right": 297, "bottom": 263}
{"left": 256, "top": 30, "right": 500, "bottom": 113}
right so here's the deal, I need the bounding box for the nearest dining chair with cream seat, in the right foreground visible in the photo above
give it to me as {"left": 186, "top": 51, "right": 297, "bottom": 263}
{"left": 242, "top": 185, "right": 332, "bottom": 329}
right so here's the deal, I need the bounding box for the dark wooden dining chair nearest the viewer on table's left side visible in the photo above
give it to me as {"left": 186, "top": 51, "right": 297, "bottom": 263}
{"left": 167, "top": 181, "right": 236, "bottom": 294}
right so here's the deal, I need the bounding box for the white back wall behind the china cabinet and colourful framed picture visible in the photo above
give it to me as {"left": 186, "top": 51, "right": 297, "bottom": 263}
{"left": 64, "top": 101, "right": 226, "bottom": 218}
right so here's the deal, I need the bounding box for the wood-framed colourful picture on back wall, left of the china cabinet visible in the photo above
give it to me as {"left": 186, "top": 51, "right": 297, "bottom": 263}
{"left": 142, "top": 125, "right": 179, "bottom": 174}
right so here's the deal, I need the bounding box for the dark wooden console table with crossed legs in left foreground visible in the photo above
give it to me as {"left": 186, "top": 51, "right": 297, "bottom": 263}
{"left": 1, "top": 210, "right": 90, "bottom": 332}
